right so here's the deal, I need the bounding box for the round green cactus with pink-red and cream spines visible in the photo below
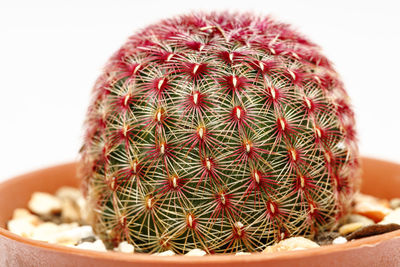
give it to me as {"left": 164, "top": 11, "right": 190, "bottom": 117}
{"left": 80, "top": 13, "right": 359, "bottom": 253}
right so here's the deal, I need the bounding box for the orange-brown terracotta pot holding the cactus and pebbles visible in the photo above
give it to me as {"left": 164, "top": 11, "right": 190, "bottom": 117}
{"left": 0, "top": 158, "right": 400, "bottom": 267}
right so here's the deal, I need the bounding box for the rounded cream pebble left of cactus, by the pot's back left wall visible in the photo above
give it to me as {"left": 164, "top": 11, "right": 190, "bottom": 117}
{"left": 28, "top": 192, "right": 61, "bottom": 215}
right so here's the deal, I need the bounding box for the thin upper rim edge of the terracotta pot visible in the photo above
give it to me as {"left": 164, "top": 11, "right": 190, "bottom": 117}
{"left": 0, "top": 158, "right": 400, "bottom": 264}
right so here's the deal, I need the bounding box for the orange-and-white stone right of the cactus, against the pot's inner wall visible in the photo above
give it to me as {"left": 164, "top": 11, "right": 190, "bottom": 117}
{"left": 354, "top": 194, "right": 391, "bottom": 222}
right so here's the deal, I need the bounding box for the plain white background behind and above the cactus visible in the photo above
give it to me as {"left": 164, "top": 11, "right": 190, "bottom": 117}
{"left": 0, "top": 0, "right": 400, "bottom": 180}
